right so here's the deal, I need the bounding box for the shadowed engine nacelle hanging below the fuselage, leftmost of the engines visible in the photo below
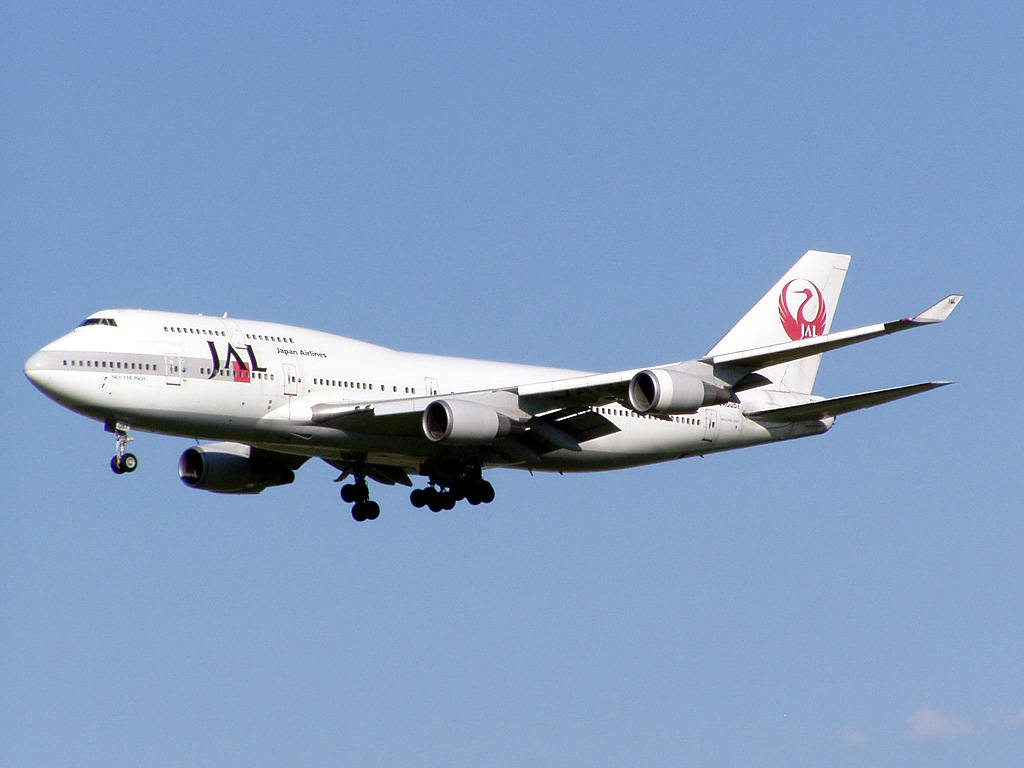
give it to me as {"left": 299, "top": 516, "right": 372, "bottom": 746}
{"left": 178, "top": 442, "right": 295, "bottom": 494}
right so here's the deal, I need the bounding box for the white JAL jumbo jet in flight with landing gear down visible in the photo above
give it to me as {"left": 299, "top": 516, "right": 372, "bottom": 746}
{"left": 25, "top": 251, "right": 963, "bottom": 522}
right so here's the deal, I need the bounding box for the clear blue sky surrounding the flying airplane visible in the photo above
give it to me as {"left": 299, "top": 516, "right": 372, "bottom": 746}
{"left": 0, "top": 2, "right": 1024, "bottom": 768}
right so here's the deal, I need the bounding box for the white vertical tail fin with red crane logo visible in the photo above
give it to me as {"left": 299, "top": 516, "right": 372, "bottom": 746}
{"left": 708, "top": 251, "right": 850, "bottom": 394}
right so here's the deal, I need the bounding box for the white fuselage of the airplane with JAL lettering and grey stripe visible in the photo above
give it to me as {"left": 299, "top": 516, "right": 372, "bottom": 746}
{"left": 26, "top": 309, "right": 831, "bottom": 472}
